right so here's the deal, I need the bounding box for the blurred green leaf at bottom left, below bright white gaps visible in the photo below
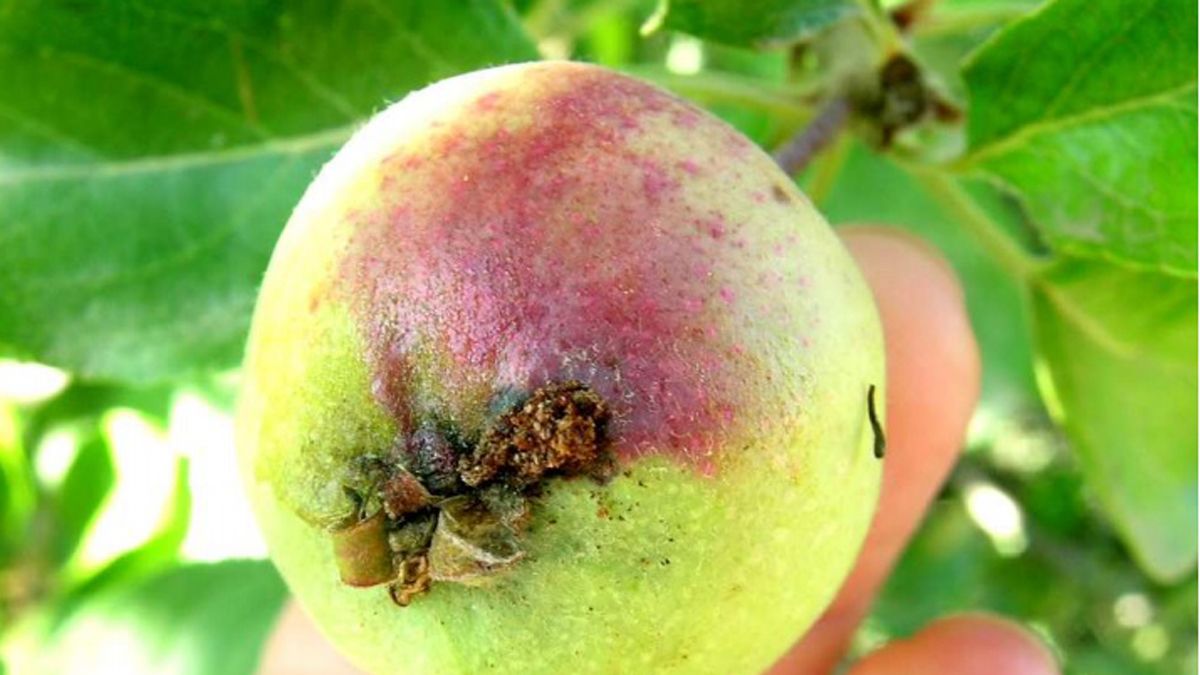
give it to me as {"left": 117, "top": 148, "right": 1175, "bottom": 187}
{"left": 22, "top": 561, "right": 287, "bottom": 675}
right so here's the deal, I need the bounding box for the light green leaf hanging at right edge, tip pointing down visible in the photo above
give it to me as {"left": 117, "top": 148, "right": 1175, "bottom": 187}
{"left": 1033, "top": 261, "right": 1198, "bottom": 580}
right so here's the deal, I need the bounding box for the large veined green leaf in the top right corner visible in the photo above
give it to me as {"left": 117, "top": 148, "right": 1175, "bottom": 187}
{"left": 965, "top": 0, "right": 1198, "bottom": 277}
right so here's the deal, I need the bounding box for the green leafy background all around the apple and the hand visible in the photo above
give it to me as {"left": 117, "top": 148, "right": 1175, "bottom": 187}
{"left": 0, "top": 0, "right": 1198, "bottom": 675}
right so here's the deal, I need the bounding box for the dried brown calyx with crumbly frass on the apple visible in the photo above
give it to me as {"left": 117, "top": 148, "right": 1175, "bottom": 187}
{"left": 334, "top": 381, "right": 612, "bottom": 607}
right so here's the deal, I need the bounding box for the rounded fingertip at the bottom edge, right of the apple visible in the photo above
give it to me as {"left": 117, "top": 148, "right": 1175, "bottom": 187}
{"left": 850, "top": 614, "right": 1060, "bottom": 675}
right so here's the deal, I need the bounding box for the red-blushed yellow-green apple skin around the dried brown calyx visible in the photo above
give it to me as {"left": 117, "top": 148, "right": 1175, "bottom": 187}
{"left": 238, "top": 62, "right": 884, "bottom": 674}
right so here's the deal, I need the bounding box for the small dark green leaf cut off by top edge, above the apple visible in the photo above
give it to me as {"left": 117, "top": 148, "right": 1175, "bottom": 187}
{"left": 650, "top": 0, "right": 860, "bottom": 47}
